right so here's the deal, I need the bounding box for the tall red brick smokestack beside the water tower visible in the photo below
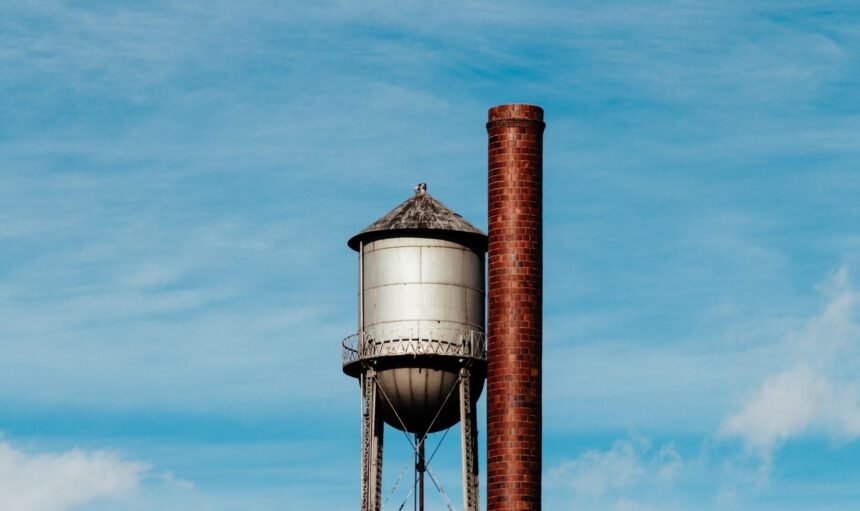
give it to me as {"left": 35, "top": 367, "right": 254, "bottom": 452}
{"left": 487, "top": 105, "right": 546, "bottom": 511}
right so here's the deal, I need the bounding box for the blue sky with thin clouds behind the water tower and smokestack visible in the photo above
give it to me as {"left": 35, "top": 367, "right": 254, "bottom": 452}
{"left": 0, "top": 0, "right": 860, "bottom": 511}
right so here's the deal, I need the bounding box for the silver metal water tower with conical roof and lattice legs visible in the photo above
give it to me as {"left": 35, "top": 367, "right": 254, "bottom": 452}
{"left": 343, "top": 184, "right": 487, "bottom": 511}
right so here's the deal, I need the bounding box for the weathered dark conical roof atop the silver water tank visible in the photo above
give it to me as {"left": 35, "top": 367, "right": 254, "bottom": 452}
{"left": 347, "top": 183, "right": 487, "bottom": 252}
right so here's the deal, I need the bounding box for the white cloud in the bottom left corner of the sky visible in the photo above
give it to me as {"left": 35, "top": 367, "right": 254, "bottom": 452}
{"left": 0, "top": 442, "right": 149, "bottom": 511}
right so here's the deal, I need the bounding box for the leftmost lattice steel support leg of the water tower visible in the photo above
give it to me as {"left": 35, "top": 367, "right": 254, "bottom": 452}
{"left": 361, "top": 369, "right": 384, "bottom": 511}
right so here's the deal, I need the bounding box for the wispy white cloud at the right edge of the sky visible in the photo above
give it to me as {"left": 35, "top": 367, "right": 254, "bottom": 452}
{"left": 720, "top": 268, "right": 860, "bottom": 459}
